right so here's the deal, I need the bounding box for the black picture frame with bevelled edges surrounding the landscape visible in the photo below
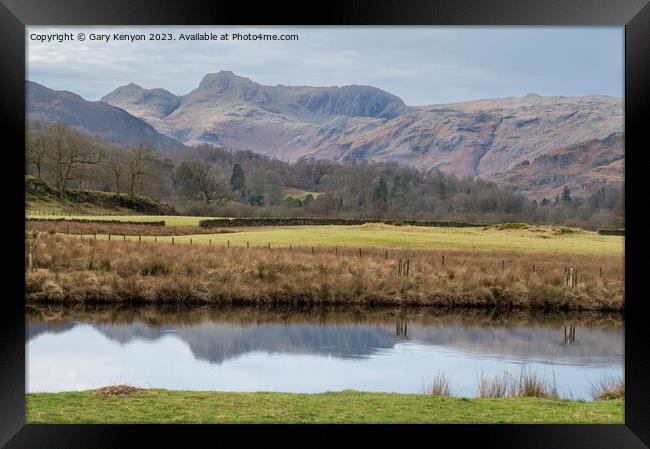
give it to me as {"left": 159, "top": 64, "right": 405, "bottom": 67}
{"left": 0, "top": 0, "right": 650, "bottom": 449}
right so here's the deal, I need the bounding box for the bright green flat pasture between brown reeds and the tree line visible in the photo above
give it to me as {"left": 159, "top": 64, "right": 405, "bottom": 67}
{"left": 36, "top": 215, "right": 624, "bottom": 256}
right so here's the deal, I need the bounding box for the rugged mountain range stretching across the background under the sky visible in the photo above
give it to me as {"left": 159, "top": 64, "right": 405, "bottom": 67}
{"left": 28, "top": 71, "right": 624, "bottom": 199}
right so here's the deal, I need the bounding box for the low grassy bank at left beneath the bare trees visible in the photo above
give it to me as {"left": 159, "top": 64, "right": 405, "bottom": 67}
{"left": 25, "top": 176, "right": 178, "bottom": 215}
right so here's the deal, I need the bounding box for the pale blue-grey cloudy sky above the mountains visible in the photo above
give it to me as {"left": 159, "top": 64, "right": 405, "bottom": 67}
{"left": 26, "top": 26, "right": 624, "bottom": 106}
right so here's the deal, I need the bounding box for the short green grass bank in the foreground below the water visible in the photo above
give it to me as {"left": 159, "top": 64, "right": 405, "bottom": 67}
{"left": 26, "top": 390, "right": 624, "bottom": 424}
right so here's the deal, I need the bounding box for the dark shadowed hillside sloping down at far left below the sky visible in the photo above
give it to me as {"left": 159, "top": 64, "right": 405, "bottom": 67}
{"left": 26, "top": 81, "right": 183, "bottom": 150}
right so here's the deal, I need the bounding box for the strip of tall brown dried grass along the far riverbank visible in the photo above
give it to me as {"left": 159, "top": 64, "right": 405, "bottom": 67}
{"left": 26, "top": 233, "right": 624, "bottom": 311}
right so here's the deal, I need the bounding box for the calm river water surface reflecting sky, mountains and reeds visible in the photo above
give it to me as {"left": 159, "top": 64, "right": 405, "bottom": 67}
{"left": 26, "top": 307, "right": 623, "bottom": 397}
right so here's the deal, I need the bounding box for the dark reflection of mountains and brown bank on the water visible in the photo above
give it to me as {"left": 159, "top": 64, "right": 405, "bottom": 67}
{"left": 27, "top": 302, "right": 624, "bottom": 366}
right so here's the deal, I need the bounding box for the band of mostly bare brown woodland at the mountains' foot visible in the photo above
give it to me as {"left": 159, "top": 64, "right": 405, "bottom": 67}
{"left": 26, "top": 123, "right": 624, "bottom": 228}
